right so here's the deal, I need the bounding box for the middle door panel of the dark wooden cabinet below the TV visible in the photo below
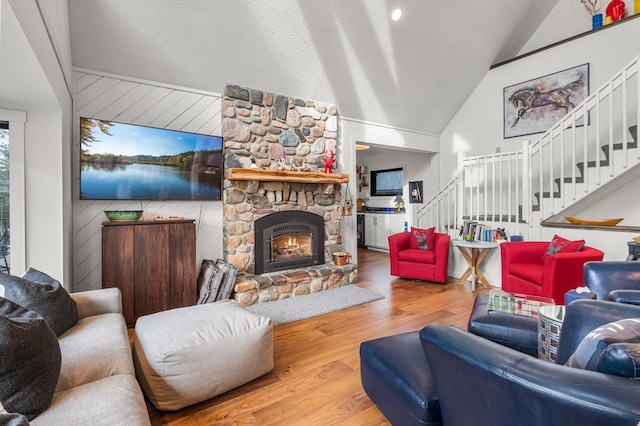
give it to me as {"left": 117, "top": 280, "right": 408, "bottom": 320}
{"left": 134, "top": 225, "right": 171, "bottom": 318}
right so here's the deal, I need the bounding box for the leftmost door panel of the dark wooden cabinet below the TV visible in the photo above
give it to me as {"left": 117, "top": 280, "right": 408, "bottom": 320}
{"left": 102, "top": 226, "right": 136, "bottom": 325}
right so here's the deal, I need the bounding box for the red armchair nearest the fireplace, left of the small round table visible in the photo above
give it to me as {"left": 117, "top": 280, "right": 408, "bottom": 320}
{"left": 388, "top": 232, "right": 451, "bottom": 283}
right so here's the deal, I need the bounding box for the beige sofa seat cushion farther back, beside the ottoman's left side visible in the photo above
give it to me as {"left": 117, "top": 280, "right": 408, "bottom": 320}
{"left": 56, "top": 313, "right": 135, "bottom": 392}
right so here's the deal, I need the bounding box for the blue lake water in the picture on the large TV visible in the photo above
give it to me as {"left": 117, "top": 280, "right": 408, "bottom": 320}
{"left": 80, "top": 163, "right": 221, "bottom": 200}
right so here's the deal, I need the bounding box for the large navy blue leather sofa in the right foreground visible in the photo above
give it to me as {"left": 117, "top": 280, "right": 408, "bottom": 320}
{"left": 360, "top": 300, "right": 640, "bottom": 426}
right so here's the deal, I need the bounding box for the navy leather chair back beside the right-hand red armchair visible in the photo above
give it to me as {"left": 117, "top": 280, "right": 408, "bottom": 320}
{"left": 584, "top": 261, "right": 640, "bottom": 299}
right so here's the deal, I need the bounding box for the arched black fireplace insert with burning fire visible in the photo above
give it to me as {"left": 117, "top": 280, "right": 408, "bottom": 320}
{"left": 254, "top": 211, "right": 324, "bottom": 274}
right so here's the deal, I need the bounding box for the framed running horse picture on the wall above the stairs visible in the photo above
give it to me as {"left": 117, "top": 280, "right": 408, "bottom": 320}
{"left": 503, "top": 63, "right": 589, "bottom": 139}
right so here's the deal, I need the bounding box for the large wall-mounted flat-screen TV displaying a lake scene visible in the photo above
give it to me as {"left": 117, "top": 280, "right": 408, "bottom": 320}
{"left": 80, "top": 117, "right": 223, "bottom": 200}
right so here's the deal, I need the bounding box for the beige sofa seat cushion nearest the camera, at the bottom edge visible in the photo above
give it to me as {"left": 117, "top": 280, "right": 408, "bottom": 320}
{"left": 31, "top": 374, "right": 150, "bottom": 426}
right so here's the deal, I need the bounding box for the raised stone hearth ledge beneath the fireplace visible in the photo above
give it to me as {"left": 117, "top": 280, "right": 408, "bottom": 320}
{"left": 233, "top": 263, "right": 358, "bottom": 306}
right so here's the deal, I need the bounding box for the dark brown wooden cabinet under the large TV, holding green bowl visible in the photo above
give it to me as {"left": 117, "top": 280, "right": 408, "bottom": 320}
{"left": 102, "top": 220, "right": 197, "bottom": 326}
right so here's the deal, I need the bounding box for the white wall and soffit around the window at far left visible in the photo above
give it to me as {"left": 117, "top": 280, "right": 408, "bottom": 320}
{"left": 0, "top": 0, "right": 72, "bottom": 286}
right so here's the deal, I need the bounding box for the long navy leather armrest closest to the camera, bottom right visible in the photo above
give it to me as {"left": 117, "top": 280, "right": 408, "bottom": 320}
{"left": 420, "top": 324, "right": 640, "bottom": 426}
